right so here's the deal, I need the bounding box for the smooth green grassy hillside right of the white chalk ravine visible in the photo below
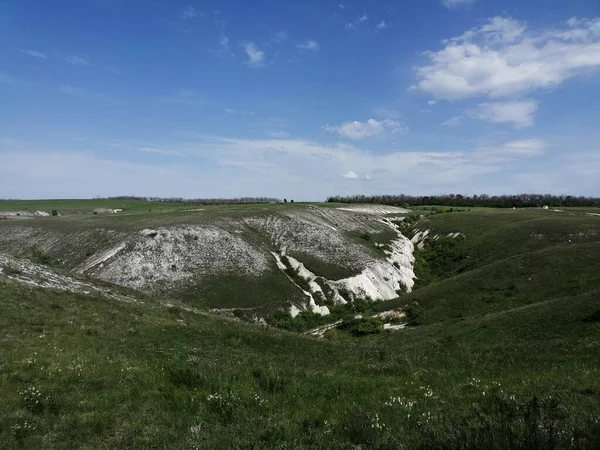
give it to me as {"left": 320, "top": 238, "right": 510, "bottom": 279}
{"left": 376, "top": 209, "right": 600, "bottom": 324}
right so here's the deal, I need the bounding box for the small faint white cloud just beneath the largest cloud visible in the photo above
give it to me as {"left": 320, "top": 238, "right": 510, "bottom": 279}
{"left": 471, "top": 100, "right": 538, "bottom": 128}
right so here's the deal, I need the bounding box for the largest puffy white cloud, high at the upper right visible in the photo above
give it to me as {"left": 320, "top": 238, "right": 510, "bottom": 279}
{"left": 413, "top": 17, "right": 600, "bottom": 100}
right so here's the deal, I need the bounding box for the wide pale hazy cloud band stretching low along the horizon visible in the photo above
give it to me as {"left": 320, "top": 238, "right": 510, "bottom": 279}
{"left": 0, "top": 132, "right": 584, "bottom": 200}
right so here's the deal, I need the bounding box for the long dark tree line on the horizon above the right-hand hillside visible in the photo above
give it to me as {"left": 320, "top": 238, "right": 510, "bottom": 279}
{"left": 327, "top": 194, "right": 600, "bottom": 208}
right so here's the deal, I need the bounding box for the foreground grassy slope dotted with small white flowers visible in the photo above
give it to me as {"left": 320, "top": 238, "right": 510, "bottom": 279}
{"left": 0, "top": 276, "right": 600, "bottom": 449}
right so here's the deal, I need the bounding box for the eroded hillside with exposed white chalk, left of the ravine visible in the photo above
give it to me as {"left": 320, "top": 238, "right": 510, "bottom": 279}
{"left": 0, "top": 205, "right": 414, "bottom": 314}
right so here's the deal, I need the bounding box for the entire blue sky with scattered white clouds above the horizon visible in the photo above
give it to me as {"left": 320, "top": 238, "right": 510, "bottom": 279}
{"left": 0, "top": 0, "right": 600, "bottom": 200}
